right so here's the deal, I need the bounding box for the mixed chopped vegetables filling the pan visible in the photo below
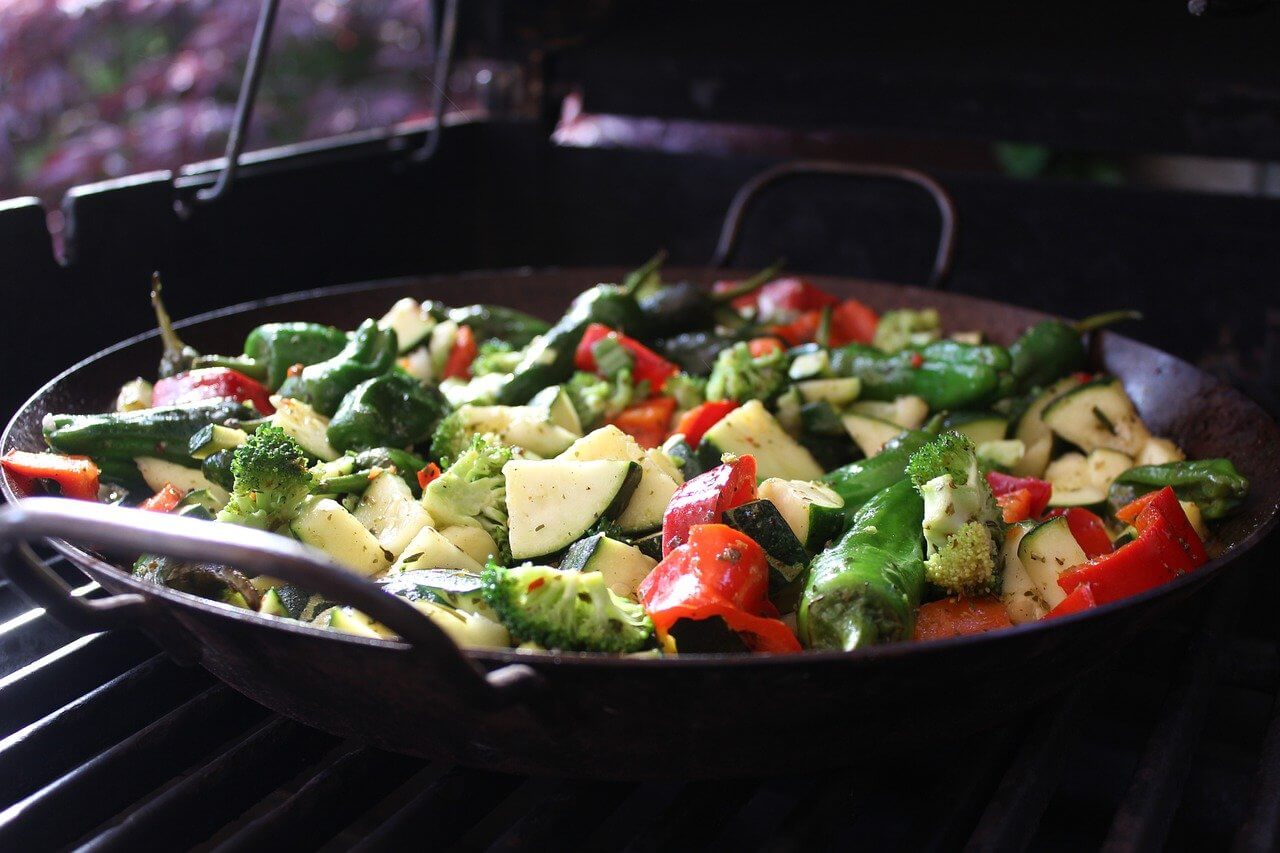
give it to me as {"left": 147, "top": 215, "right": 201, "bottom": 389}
{"left": 3, "top": 256, "right": 1248, "bottom": 654}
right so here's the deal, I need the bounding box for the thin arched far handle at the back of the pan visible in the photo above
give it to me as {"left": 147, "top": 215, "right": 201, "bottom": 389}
{"left": 712, "top": 160, "right": 956, "bottom": 287}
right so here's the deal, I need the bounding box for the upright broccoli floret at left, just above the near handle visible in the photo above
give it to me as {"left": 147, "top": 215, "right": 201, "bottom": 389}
{"left": 218, "top": 424, "right": 315, "bottom": 530}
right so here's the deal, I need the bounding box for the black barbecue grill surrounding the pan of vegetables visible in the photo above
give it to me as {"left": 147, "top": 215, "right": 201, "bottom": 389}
{"left": 0, "top": 4, "right": 1280, "bottom": 849}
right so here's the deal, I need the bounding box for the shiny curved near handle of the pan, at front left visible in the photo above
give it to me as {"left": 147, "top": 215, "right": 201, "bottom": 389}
{"left": 0, "top": 498, "right": 541, "bottom": 707}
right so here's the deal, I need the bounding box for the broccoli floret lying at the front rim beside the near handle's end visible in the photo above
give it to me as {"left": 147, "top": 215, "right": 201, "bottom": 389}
{"left": 484, "top": 565, "right": 653, "bottom": 652}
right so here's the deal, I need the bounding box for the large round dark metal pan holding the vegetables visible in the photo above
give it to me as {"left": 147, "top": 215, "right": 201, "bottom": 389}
{"left": 0, "top": 269, "right": 1280, "bottom": 779}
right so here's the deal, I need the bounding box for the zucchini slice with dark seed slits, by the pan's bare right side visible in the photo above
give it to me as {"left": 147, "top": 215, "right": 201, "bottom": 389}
{"left": 1043, "top": 377, "right": 1151, "bottom": 456}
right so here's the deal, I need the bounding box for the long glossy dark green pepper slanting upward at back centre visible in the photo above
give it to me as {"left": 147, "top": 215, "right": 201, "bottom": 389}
{"left": 495, "top": 284, "right": 640, "bottom": 406}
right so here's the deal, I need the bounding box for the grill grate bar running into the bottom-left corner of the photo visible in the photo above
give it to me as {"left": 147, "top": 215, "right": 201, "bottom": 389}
{"left": 0, "top": 685, "right": 266, "bottom": 850}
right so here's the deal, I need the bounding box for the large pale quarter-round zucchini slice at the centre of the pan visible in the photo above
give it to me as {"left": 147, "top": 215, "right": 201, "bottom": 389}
{"left": 502, "top": 459, "right": 641, "bottom": 560}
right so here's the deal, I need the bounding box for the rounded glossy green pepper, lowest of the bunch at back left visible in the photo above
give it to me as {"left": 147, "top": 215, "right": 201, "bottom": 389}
{"left": 328, "top": 370, "right": 449, "bottom": 451}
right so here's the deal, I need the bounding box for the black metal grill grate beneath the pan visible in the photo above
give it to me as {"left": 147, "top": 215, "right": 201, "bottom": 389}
{"left": 0, "top": 546, "right": 1280, "bottom": 850}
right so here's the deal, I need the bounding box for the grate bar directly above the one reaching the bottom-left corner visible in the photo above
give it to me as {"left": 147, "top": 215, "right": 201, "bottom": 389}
{"left": 0, "top": 654, "right": 210, "bottom": 806}
